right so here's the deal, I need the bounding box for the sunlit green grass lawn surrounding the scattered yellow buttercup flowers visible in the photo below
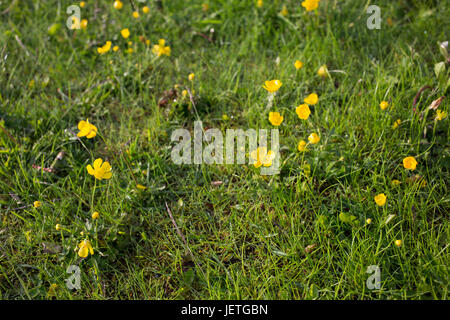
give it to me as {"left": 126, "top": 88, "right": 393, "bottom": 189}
{"left": 0, "top": 0, "right": 450, "bottom": 299}
